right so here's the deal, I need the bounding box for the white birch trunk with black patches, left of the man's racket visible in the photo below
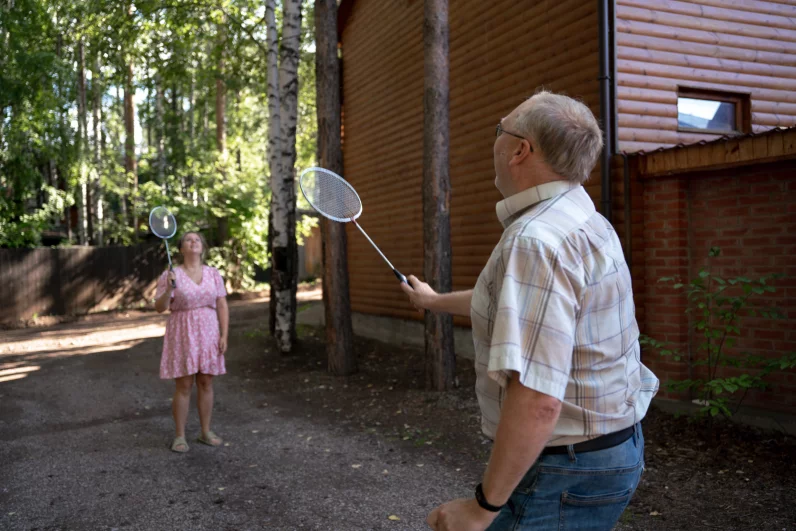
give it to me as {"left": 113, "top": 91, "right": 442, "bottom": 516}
{"left": 269, "top": 0, "right": 301, "bottom": 353}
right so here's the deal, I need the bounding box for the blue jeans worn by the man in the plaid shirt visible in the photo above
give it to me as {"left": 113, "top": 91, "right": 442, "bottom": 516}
{"left": 487, "top": 423, "right": 644, "bottom": 531}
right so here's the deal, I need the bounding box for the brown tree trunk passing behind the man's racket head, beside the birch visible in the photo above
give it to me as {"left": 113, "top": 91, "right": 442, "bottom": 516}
{"left": 315, "top": 0, "right": 357, "bottom": 376}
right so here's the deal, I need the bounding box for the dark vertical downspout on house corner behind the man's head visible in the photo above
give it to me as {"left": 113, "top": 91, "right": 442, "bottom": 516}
{"left": 598, "top": 0, "right": 614, "bottom": 222}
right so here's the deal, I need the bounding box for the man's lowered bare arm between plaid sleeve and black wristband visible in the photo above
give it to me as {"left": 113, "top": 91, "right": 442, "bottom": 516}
{"left": 483, "top": 373, "right": 561, "bottom": 505}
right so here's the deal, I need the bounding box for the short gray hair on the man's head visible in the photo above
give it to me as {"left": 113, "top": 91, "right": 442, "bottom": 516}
{"left": 515, "top": 90, "right": 603, "bottom": 183}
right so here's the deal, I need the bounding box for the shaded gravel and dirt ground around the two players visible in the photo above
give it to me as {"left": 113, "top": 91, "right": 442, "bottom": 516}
{"left": 0, "top": 298, "right": 796, "bottom": 531}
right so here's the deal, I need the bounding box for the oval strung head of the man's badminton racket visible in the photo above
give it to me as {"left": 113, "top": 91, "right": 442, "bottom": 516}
{"left": 299, "top": 167, "right": 362, "bottom": 223}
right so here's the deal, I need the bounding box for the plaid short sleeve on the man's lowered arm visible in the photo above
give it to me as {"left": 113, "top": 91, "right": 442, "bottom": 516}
{"left": 488, "top": 238, "right": 579, "bottom": 400}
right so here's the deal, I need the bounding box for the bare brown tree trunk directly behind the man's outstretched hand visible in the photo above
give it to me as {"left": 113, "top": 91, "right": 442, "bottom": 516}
{"left": 423, "top": 0, "right": 456, "bottom": 391}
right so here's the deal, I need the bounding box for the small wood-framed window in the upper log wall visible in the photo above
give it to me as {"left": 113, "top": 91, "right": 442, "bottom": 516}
{"left": 677, "top": 88, "right": 751, "bottom": 135}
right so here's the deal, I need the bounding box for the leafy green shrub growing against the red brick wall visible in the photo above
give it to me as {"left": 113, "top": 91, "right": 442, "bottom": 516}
{"left": 640, "top": 247, "right": 796, "bottom": 418}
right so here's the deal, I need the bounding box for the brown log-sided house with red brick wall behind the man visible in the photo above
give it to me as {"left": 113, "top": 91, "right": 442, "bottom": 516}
{"left": 338, "top": 0, "right": 796, "bottom": 414}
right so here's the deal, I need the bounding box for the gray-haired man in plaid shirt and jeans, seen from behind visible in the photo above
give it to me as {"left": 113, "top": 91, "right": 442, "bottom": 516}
{"left": 402, "top": 92, "right": 658, "bottom": 531}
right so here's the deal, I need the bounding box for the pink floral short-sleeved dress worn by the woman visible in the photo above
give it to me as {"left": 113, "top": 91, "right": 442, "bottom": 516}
{"left": 156, "top": 265, "right": 227, "bottom": 379}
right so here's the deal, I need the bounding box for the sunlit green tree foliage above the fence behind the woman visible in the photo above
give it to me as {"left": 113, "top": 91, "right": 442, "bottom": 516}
{"left": 0, "top": 0, "right": 317, "bottom": 289}
